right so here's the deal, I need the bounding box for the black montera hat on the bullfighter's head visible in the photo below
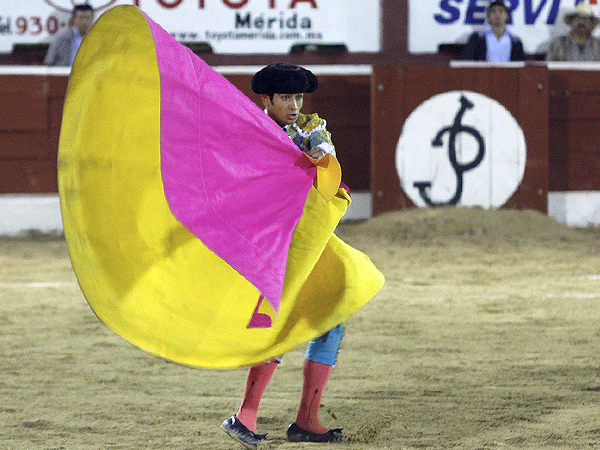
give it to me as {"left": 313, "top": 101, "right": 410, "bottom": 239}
{"left": 250, "top": 62, "right": 319, "bottom": 95}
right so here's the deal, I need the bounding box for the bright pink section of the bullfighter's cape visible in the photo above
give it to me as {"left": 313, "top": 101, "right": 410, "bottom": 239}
{"left": 145, "top": 15, "right": 316, "bottom": 311}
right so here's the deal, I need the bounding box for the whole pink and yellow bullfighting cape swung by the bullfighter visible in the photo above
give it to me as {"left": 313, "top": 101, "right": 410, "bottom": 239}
{"left": 58, "top": 6, "right": 383, "bottom": 368}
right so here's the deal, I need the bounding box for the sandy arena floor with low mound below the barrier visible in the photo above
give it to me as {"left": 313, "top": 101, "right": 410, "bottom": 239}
{"left": 0, "top": 209, "right": 600, "bottom": 450}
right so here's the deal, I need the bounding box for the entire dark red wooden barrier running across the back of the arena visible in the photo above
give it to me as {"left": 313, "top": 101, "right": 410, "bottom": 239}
{"left": 0, "top": 63, "right": 600, "bottom": 221}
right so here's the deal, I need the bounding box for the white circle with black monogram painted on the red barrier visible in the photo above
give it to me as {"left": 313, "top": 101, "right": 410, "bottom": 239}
{"left": 396, "top": 91, "right": 526, "bottom": 209}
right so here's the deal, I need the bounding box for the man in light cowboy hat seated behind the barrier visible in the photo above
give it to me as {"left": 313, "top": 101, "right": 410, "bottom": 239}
{"left": 546, "top": 1, "right": 600, "bottom": 61}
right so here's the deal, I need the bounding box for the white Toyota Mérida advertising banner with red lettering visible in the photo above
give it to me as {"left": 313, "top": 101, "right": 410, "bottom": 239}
{"left": 0, "top": 0, "right": 381, "bottom": 54}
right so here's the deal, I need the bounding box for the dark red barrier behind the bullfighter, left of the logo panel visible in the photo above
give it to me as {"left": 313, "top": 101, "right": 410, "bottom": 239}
{"left": 0, "top": 66, "right": 371, "bottom": 194}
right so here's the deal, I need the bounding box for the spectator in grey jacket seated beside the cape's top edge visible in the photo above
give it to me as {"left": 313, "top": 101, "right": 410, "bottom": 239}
{"left": 44, "top": 4, "right": 94, "bottom": 66}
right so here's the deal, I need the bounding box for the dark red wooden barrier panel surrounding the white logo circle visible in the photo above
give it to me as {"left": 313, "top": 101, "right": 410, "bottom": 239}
{"left": 371, "top": 63, "right": 549, "bottom": 214}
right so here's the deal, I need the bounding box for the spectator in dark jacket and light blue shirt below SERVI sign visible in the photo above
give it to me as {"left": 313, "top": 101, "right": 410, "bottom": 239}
{"left": 463, "top": 0, "right": 525, "bottom": 62}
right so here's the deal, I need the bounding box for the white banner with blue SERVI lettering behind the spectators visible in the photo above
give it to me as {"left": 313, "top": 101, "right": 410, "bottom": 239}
{"left": 408, "top": 0, "right": 600, "bottom": 53}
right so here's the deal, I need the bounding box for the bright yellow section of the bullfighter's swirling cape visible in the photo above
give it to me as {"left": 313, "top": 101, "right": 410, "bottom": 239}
{"left": 58, "top": 6, "right": 383, "bottom": 368}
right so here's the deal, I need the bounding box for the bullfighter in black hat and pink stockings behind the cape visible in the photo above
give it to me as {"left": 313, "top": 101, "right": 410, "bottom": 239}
{"left": 221, "top": 63, "right": 344, "bottom": 449}
